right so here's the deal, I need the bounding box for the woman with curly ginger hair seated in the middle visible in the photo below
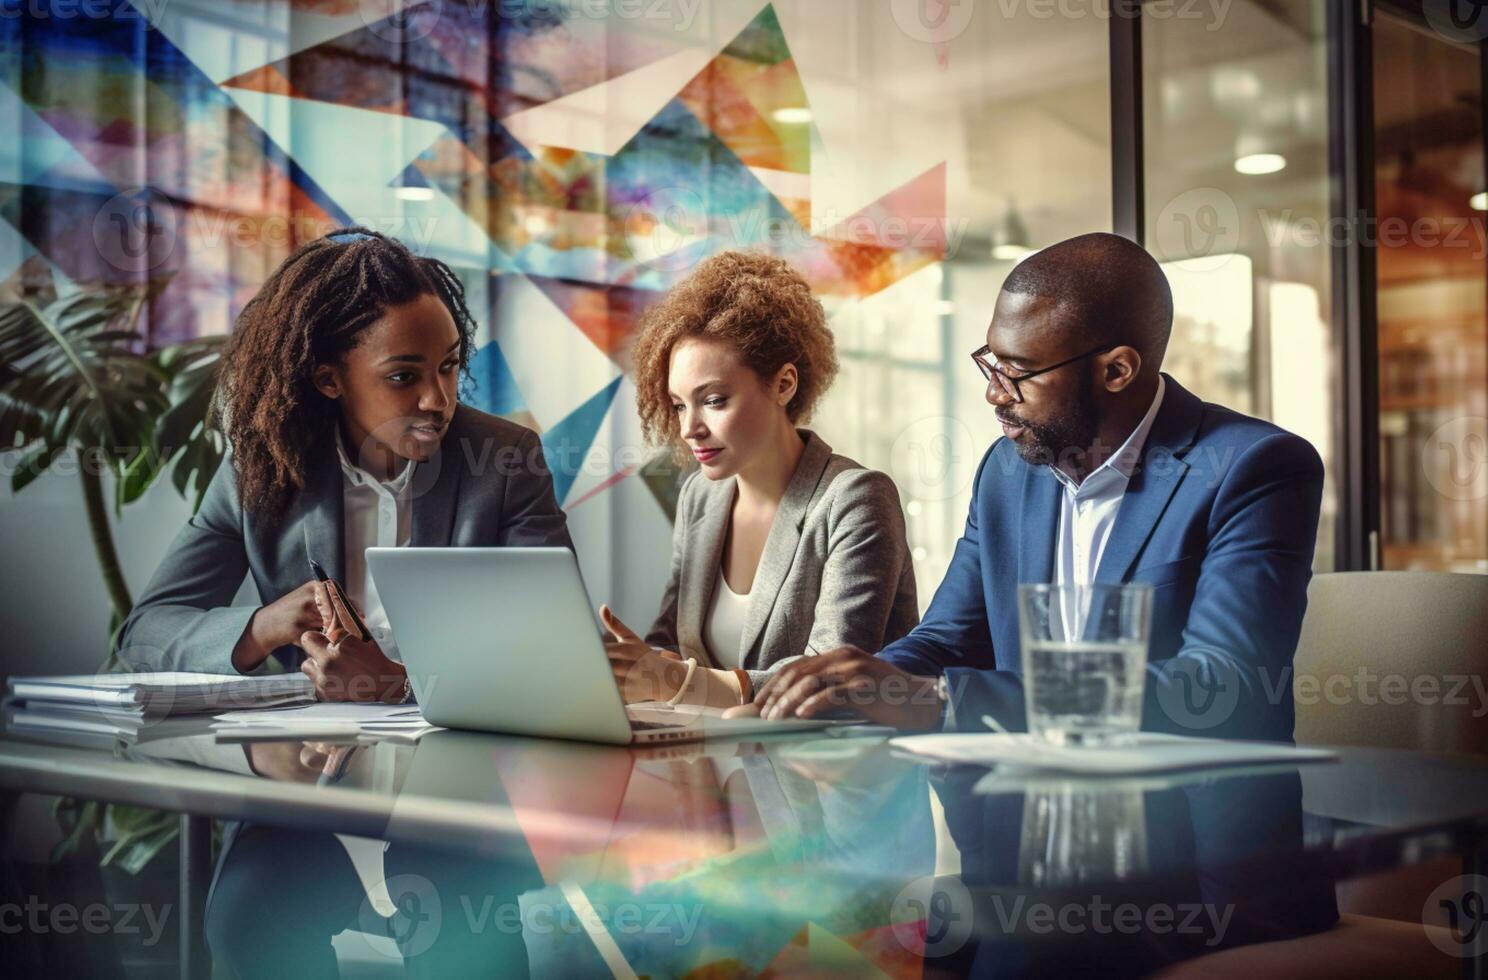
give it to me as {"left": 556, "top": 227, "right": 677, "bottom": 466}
{"left": 600, "top": 251, "right": 918, "bottom": 706}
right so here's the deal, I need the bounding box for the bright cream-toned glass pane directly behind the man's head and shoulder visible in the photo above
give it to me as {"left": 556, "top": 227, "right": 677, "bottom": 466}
{"left": 1143, "top": 0, "right": 1342, "bottom": 571}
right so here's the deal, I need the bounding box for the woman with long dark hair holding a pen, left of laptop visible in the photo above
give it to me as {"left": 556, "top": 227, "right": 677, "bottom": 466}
{"left": 121, "top": 228, "right": 573, "bottom": 700}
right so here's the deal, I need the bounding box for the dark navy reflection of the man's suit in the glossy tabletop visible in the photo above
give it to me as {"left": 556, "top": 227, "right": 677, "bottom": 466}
{"left": 926, "top": 770, "right": 1338, "bottom": 976}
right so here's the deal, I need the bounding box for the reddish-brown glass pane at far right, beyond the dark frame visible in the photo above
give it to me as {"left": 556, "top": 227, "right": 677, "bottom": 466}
{"left": 1373, "top": 15, "right": 1488, "bottom": 571}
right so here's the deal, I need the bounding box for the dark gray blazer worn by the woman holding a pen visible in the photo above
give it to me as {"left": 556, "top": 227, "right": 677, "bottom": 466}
{"left": 119, "top": 404, "right": 573, "bottom": 674}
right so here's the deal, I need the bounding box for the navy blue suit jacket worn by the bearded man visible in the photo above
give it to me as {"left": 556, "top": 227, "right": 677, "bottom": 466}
{"left": 879, "top": 375, "right": 1323, "bottom": 739}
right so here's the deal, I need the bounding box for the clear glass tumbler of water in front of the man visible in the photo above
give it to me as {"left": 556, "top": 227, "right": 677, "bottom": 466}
{"left": 1018, "top": 584, "right": 1152, "bottom": 745}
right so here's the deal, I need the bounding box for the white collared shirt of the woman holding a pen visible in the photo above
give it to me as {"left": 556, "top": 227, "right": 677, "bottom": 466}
{"left": 336, "top": 433, "right": 414, "bottom": 660}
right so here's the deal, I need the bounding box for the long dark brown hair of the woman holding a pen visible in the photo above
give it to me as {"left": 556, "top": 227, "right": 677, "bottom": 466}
{"left": 219, "top": 228, "right": 475, "bottom": 519}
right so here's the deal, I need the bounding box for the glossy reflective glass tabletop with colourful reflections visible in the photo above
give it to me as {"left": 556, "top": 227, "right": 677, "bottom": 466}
{"left": 0, "top": 729, "right": 1488, "bottom": 976}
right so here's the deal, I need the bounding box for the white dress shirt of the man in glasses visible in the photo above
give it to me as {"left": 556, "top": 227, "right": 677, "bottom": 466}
{"left": 1049, "top": 375, "right": 1167, "bottom": 584}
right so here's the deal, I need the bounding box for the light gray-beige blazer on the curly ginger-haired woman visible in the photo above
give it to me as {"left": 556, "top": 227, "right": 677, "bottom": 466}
{"left": 646, "top": 428, "right": 920, "bottom": 687}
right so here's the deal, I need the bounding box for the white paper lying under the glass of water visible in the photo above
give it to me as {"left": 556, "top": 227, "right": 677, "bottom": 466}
{"left": 890, "top": 732, "right": 1336, "bottom": 776}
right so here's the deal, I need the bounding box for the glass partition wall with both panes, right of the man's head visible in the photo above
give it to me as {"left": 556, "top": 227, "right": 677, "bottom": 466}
{"left": 1140, "top": 0, "right": 1488, "bottom": 573}
